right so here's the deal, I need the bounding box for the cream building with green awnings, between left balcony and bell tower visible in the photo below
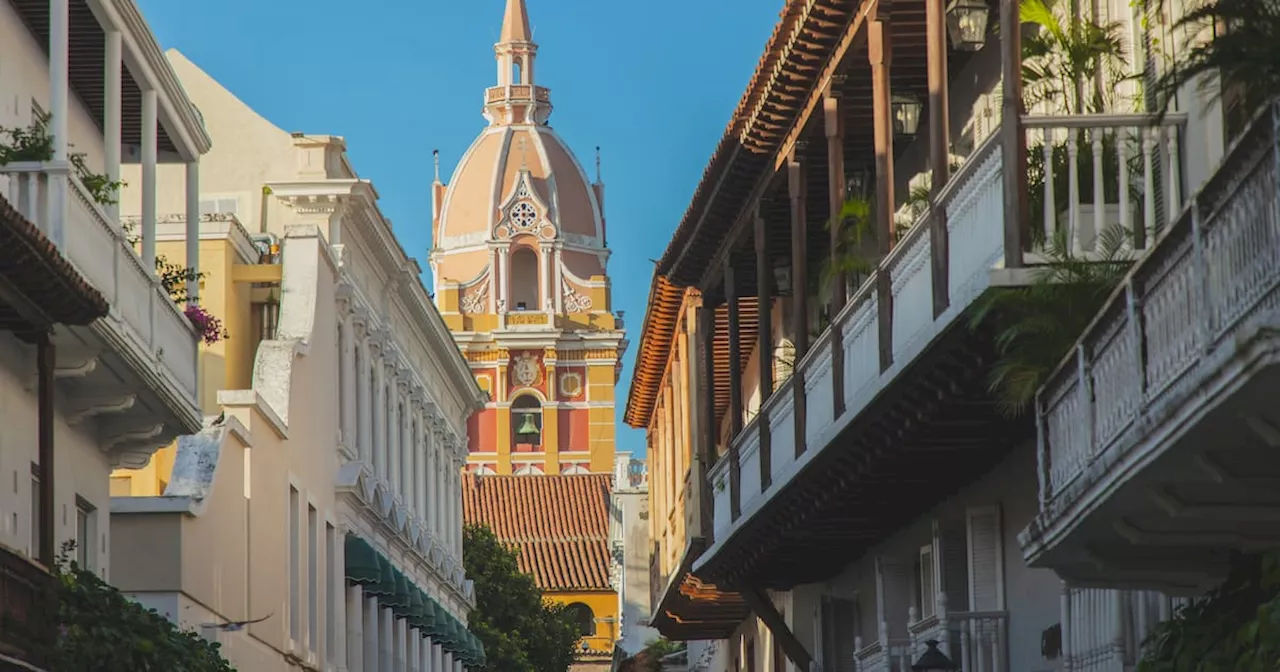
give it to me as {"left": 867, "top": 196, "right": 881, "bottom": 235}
{"left": 103, "top": 51, "right": 484, "bottom": 672}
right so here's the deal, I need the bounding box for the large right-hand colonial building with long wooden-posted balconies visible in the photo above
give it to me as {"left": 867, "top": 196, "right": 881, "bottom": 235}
{"left": 627, "top": 0, "right": 1254, "bottom": 672}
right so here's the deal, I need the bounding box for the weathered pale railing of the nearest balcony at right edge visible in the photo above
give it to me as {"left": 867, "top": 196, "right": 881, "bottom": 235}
{"left": 1037, "top": 108, "right": 1280, "bottom": 501}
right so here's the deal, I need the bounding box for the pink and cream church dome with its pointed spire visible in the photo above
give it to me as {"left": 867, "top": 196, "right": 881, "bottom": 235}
{"left": 431, "top": 0, "right": 608, "bottom": 293}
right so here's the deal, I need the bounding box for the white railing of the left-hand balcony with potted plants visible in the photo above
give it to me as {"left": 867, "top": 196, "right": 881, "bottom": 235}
{"left": 0, "top": 163, "right": 198, "bottom": 407}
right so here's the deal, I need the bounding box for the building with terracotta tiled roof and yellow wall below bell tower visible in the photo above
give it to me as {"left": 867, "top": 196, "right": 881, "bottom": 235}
{"left": 463, "top": 474, "right": 621, "bottom": 672}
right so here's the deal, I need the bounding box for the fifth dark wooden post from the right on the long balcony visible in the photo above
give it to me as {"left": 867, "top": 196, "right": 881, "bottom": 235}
{"left": 787, "top": 150, "right": 809, "bottom": 457}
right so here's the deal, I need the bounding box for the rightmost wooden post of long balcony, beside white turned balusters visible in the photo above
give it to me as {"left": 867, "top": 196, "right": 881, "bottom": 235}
{"left": 1000, "top": 0, "right": 1029, "bottom": 269}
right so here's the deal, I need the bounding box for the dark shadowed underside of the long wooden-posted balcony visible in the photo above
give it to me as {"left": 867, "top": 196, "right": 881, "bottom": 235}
{"left": 696, "top": 316, "right": 1034, "bottom": 590}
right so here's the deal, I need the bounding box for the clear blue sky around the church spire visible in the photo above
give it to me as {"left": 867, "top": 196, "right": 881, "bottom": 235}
{"left": 138, "top": 0, "right": 783, "bottom": 453}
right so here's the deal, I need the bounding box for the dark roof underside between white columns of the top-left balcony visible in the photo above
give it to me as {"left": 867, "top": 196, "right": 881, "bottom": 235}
{"left": 8, "top": 0, "right": 179, "bottom": 154}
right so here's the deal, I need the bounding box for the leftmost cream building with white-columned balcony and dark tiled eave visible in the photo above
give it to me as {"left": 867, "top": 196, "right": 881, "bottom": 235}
{"left": 0, "top": 0, "right": 210, "bottom": 667}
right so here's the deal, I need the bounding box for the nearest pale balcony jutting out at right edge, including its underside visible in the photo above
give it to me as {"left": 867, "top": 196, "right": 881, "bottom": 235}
{"left": 1020, "top": 105, "right": 1280, "bottom": 593}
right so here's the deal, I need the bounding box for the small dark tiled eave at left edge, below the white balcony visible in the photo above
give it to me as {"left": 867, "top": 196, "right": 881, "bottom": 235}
{"left": 0, "top": 196, "right": 109, "bottom": 335}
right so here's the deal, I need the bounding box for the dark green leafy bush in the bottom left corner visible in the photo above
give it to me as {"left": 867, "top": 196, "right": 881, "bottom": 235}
{"left": 4, "top": 543, "right": 234, "bottom": 672}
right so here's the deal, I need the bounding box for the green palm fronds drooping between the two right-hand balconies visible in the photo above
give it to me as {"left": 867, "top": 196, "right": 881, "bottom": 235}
{"left": 969, "top": 227, "right": 1130, "bottom": 416}
